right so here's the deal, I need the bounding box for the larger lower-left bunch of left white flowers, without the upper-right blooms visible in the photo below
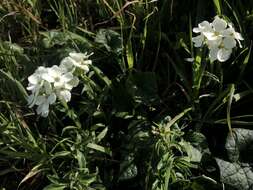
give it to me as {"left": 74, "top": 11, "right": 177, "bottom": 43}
{"left": 27, "top": 65, "right": 79, "bottom": 117}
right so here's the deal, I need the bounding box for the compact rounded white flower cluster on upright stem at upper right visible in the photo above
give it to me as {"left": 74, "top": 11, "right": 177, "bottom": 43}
{"left": 192, "top": 16, "right": 243, "bottom": 62}
